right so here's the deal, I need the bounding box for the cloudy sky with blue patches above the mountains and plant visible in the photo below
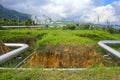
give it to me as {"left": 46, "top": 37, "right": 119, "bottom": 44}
{"left": 0, "top": 0, "right": 120, "bottom": 24}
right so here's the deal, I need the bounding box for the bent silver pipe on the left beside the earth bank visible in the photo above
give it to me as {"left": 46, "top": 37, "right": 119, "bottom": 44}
{"left": 0, "top": 43, "right": 29, "bottom": 64}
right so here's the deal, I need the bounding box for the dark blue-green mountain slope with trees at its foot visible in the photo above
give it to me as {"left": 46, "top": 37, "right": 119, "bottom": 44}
{"left": 0, "top": 4, "right": 35, "bottom": 26}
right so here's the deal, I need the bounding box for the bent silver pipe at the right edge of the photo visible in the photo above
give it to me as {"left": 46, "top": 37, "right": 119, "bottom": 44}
{"left": 98, "top": 40, "right": 120, "bottom": 60}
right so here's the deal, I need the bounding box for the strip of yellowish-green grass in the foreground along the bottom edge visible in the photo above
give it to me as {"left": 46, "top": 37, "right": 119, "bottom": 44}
{"left": 0, "top": 67, "right": 120, "bottom": 80}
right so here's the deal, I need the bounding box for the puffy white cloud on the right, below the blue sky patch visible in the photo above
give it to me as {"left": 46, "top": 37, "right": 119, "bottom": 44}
{"left": 82, "top": 5, "right": 118, "bottom": 23}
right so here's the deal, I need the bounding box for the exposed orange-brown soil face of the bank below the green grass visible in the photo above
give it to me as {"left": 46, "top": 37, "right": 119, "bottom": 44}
{"left": 29, "top": 45, "right": 114, "bottom": 68}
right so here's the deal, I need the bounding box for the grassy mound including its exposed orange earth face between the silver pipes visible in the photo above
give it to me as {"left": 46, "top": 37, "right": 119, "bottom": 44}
{"left": 0, "top": 29, "right": 120, "bottom": 67}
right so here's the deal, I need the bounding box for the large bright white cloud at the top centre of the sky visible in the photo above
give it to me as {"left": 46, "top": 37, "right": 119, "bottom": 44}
{"left": 39, "top": 0, "right": 94, "bottom": 18}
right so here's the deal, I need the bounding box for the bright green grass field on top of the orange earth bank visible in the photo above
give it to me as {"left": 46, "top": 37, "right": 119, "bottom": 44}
{"left": 0, "top": 29, "right": 120, "bottom": 49}
